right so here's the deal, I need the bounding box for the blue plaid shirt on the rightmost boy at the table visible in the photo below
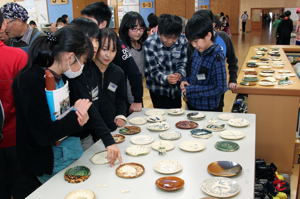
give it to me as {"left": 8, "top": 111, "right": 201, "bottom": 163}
{"left": 185, "top": 44, "right": 227, "bottom": 110}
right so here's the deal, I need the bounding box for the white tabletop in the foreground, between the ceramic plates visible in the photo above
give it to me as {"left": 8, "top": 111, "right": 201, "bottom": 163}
{"left": 27, "top": 109, "right": 256, "bottom": 199}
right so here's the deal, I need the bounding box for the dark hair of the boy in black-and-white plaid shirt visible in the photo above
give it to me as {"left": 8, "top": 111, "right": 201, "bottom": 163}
{"left": 158, "top": 14, "right": 182, "bottom": 37}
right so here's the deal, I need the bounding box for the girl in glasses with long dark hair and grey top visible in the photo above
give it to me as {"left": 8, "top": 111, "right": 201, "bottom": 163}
{"left": 119, "top": 11, "right": 147, "bottom": 112}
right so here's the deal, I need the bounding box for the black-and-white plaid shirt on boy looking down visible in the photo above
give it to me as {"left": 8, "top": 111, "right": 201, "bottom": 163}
{"left": 144, "top": 34, "right": 187, "bottom": 98}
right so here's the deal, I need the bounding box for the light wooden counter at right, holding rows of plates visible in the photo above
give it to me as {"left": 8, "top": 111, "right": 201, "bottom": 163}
{"left": 237, "top": 45, "right": 300, "bottom": 173}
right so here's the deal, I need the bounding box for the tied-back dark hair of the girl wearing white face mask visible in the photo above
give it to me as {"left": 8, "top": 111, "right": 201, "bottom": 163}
{"left": 26, "top": 26, "right": 93, "bottom": 68}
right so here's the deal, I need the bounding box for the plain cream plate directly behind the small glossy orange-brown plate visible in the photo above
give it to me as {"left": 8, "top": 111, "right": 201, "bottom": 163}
{"left": 154, "top": 160, "right": 182, "bottom": 174}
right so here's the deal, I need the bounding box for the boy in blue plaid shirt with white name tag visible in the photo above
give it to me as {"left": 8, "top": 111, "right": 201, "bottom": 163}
{"left": 180, "top": 16, "right": 227, "bottom": 111}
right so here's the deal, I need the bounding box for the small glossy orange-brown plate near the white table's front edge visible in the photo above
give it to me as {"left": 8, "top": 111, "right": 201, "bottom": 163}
{"left": 155, "top": 176, "right": 184, "bottom": 191}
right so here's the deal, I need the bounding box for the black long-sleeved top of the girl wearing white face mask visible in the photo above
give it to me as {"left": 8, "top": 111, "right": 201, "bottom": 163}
{"left": 13, "top": 67, "right": 81, "bottom": 176}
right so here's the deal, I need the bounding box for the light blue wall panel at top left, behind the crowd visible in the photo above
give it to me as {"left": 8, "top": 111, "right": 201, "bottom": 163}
{"left": 47, "top": 0, "right": 73, "bottom": 23}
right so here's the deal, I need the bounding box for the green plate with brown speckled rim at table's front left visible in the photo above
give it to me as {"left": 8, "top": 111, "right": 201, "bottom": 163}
{"left": 64, "top": 166, "right": 91, "bottom": 183}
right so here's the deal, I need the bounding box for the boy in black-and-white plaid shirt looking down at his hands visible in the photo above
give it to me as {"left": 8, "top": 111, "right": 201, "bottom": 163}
{"left": 144, "top": 14, "right": 187, "bottom": 108}
